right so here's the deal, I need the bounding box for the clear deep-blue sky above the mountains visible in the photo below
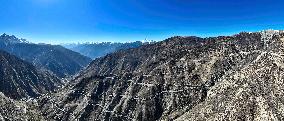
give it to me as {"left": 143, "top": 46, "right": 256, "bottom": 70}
{"left": 0, "top": 0, "right": 284, "bottom": 43}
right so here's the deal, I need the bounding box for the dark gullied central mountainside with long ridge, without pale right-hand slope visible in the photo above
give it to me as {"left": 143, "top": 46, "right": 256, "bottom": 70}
{"left": 36, "top": 30, "right": 284, "bottom": 120}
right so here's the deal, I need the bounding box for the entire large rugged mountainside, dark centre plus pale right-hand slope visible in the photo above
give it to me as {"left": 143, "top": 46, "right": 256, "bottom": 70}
{"left": 39, "top": 31, "right": 284, "bottom": 121}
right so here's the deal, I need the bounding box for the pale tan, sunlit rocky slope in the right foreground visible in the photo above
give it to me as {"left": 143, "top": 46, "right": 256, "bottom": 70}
{"left": 177, "top": 31, "right": 284, "bottom": 121}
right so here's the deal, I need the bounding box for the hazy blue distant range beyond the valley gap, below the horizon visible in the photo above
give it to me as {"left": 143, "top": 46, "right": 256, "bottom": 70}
{"left": 62, "top": 41, "right": 155, "bottom": 59}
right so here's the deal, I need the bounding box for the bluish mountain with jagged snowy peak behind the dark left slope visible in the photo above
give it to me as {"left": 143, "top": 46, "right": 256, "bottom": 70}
{"left": 0, "top": 34, "right": 91, "bottom": 78}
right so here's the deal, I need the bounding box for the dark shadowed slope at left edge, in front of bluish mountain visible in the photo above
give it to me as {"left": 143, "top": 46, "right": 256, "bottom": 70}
{"left": 0, "top": 51, "right": 63, "bottom": 99}
